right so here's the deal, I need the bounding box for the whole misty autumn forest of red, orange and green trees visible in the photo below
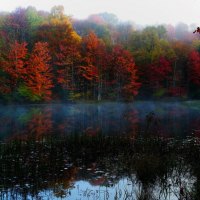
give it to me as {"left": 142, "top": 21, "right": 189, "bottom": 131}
{"left": 0, "top": 6, "right": 200, "bottom": 103}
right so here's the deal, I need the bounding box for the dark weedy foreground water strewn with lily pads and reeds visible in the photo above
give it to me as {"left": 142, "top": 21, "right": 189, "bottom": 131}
{"left": 0, "top": 135, "right": 200, "bottom": 200}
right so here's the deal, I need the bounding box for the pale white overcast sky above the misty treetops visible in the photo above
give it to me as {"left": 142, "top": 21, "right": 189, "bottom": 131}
{"left": 0, "top": 0, "right": 200, "bottom": 25}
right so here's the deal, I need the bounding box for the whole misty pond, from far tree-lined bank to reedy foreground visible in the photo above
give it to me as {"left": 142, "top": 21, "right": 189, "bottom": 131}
{"left": 0, "top": 101, "right": 200, "bottom": 200}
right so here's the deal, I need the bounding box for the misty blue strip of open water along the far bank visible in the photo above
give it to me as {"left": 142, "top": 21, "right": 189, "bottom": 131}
{"left": 0, "top": 102, "right": 200, "bottom": 139}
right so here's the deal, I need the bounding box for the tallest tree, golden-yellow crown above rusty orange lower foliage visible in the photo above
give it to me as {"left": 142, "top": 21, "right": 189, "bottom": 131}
{"left": 37, "top": 6, "right": 81, "bottom": 98}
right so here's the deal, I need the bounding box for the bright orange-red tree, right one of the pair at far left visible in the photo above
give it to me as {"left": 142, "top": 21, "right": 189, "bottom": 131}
{"left": 26, "top": 42, "right": 53, "bottom": 100}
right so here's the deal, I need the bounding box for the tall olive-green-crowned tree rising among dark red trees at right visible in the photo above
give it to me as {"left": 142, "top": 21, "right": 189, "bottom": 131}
{"left": 128, "top": 26, "right": 175, "bottom": 97}
